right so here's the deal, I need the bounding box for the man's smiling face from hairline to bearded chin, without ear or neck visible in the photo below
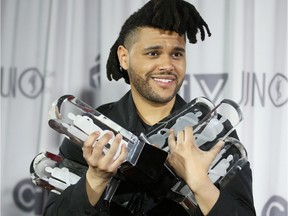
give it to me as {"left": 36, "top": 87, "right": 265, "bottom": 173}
{"left": 122, "top": 27, "right": 186, "bottom": 103}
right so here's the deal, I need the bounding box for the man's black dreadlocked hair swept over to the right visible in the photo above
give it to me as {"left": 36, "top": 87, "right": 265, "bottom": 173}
{"left": 106, "top": 0, "right": 211, "bottom": 84}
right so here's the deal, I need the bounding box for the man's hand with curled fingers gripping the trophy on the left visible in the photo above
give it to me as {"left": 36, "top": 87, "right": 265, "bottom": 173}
{"left": 83, "top": 131, "right": 127, "bottom": 205}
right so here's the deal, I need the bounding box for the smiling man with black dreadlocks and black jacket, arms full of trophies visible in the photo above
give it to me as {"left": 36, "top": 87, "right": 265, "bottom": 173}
{"left": 45, "top": 0, "right": 255, "bottom": 216}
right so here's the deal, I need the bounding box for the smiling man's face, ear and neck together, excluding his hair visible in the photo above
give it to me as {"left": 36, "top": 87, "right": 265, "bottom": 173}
{"left": 117, "top": 27, "right": 186, "bottom": 125}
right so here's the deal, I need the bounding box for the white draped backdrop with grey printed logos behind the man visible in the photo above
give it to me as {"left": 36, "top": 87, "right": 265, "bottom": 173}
{"left": 0, "top": 0, "right": 288, "bottom": 216}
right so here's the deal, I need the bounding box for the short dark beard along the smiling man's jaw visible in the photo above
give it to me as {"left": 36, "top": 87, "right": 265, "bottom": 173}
{"left": 129, "top": 70, "right": 183, "bottom": 104}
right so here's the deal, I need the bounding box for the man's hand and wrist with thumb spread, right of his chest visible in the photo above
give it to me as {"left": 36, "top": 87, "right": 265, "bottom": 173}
{"left": 167, "top": 127, "right": 224, "bottom": 215}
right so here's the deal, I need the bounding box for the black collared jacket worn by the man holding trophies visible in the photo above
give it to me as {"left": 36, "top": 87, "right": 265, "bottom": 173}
{"left": 44, "top": 91, "right": 255, "bottom": 216}
